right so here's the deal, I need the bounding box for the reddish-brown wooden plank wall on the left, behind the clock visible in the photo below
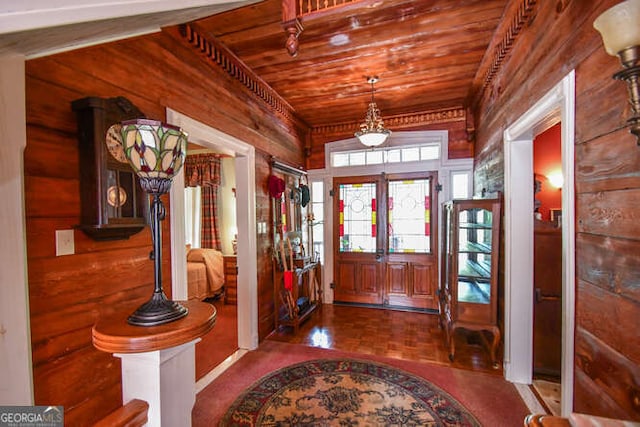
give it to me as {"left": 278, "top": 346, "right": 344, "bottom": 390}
{"left": 25, "top": 28, "right": 305, "bottom": 425}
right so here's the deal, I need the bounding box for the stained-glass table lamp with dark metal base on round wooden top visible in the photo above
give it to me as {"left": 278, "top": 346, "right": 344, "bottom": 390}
{"left": 112, "top": 119, "right": 187, "bottom": 326}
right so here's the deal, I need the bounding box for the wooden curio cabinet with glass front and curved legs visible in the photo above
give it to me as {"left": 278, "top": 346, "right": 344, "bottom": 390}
{"left": 439, "top": 199, "right": 501, "bottom": 367}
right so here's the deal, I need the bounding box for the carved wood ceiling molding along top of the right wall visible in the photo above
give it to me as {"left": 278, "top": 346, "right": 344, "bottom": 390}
{"left": 472, "top": 0, "right": 538, "bottom": 105}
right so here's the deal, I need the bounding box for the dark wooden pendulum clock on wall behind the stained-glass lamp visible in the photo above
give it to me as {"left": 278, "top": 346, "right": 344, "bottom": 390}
{"left": 71, "top": 97, "right": 148, "bottom": 240}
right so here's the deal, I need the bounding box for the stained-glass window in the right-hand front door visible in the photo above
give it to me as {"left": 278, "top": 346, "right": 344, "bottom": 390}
{"left": 388, "top": 178, "right": 431, "bottom": 253}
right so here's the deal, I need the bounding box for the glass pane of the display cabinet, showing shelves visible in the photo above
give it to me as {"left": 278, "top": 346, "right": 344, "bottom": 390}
{"left": 458, "top": 208, "right": 492, "bottom": 304}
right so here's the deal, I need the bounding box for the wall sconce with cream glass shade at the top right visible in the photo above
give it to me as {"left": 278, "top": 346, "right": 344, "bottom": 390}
{"left": 593, "top": 0, "right": 640, "bottom": 145}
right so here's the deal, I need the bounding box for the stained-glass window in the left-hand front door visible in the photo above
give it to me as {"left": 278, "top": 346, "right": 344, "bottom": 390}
{"left": 338, "top": 183, "right": 377, "bottom": 253}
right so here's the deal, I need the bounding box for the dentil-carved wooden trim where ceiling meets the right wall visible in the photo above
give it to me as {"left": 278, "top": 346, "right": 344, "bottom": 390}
{"left": 476, "top": 0, "right": 538, "bottom": 100}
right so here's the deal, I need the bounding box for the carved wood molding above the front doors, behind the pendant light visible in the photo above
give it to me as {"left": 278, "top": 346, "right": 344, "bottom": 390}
{"left": 312, "top": 107, "right": 467, "bottom": 135}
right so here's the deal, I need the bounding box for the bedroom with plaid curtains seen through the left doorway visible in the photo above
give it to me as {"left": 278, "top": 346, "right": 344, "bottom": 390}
{"left": 184, "top": 143, "right": 238, "bottom": 379}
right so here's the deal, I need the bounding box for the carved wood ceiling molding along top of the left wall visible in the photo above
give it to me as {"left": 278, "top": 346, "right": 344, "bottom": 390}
{"left": 180, "top": 24, "right": 308, "bottom": 127}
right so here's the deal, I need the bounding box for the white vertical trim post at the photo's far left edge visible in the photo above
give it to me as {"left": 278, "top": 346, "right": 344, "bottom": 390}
{"left": 0, "top": 55, "right": 33, "bottom": 405}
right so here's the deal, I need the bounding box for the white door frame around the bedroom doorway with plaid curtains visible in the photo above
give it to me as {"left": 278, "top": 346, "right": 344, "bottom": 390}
{"left": 167, "top": 108, "right": 258, "bottom": 351}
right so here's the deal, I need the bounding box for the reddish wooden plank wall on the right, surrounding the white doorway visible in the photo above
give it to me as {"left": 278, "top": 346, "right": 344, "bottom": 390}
{"left": 475, "top": 0, "right": 640, "bottom": 421}
